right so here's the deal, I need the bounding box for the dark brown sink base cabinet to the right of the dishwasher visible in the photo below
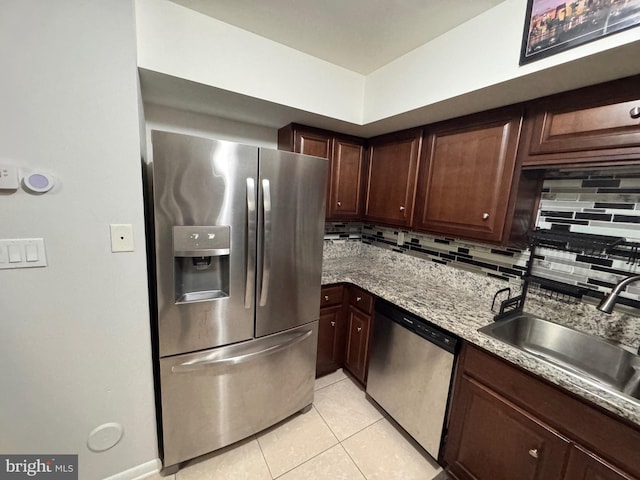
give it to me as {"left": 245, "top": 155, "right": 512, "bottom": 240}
{"left": 441, "top": 343, "right": 640, "bottom": 480}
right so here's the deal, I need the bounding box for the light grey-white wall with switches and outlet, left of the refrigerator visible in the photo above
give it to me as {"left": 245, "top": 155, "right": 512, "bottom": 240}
{"left": 0, "top": 0, "right": 158, "bottom": 480}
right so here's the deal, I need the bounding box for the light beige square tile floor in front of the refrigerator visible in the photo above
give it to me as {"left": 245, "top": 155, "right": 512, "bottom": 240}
{"left": 150, "top": 370, "right": 442, "bottom": 480}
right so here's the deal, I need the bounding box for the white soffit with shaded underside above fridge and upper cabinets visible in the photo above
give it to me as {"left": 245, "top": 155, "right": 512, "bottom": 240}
{"left": 141, "top": 0, "right": 640, "bottom": 137}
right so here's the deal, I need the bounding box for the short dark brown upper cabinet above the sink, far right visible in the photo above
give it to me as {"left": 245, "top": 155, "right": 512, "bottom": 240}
{"left": 523, "top": 76, "right": 640, "bottom": 167}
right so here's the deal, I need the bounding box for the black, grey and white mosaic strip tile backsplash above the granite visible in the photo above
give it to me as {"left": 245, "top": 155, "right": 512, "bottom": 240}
{"left": 325, "top": 171, "right": 640, "bottom": 307}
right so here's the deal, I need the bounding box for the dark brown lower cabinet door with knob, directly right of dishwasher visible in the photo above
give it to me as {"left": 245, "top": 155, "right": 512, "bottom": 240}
{"left": 445, "top": 375, "right": 569, "bottom": 480}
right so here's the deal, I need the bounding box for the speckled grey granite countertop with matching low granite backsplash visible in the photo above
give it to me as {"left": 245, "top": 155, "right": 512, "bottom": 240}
{"left": 322, "top": 242, "right": 640, "bottom": 425}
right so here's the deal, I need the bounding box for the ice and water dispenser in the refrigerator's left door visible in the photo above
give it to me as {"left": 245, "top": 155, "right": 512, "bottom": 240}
{"left": 173, "top": 225, "right": 231, "bottom": 304}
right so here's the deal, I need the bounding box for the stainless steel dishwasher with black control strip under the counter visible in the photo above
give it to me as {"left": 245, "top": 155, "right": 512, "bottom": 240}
{"left": 367, "top": 301, "right": 458, "bottom": 459}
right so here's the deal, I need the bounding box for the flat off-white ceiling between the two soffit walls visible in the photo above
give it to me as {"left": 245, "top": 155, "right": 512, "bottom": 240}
{"left": 172, "top": 0, "right": 504, "bottom": 75}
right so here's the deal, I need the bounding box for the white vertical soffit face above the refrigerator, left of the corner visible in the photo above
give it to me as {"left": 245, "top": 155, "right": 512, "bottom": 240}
{"left": 136, "top": 0, "right": 364, "bottom": 123}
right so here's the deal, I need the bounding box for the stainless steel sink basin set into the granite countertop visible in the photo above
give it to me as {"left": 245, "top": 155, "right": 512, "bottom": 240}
{"left": 478, "top": 315, "right": 640, "bottom": 401}
